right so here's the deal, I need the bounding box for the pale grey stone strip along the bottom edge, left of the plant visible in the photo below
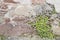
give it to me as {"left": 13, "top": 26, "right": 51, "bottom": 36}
{"left": 6, "top": 35, "right": 42, "bottom": 40}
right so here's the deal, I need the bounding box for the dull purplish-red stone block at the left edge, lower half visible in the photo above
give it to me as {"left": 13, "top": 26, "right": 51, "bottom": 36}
{"left": 0, "top": 24, "right": 12, "bottom": 36}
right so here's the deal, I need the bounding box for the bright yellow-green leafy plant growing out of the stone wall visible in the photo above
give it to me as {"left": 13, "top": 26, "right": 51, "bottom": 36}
{"left": 30, "top": 16, "right": 54, "bottom": 39}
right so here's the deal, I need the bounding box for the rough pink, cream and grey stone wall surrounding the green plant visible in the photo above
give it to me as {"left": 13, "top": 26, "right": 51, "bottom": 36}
{"left": 0, "top": 0, "right": 60, "bottom": 40}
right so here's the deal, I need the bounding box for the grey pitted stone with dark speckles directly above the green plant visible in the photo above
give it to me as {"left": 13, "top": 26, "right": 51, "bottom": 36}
{"left": 33, "top": 3, "right": 54, "bottom": 16}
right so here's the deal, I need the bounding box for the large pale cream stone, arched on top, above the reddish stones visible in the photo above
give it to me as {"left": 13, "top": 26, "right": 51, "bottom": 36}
{"left": 4, "top": 5, "right": 36, "bottom": 23}
